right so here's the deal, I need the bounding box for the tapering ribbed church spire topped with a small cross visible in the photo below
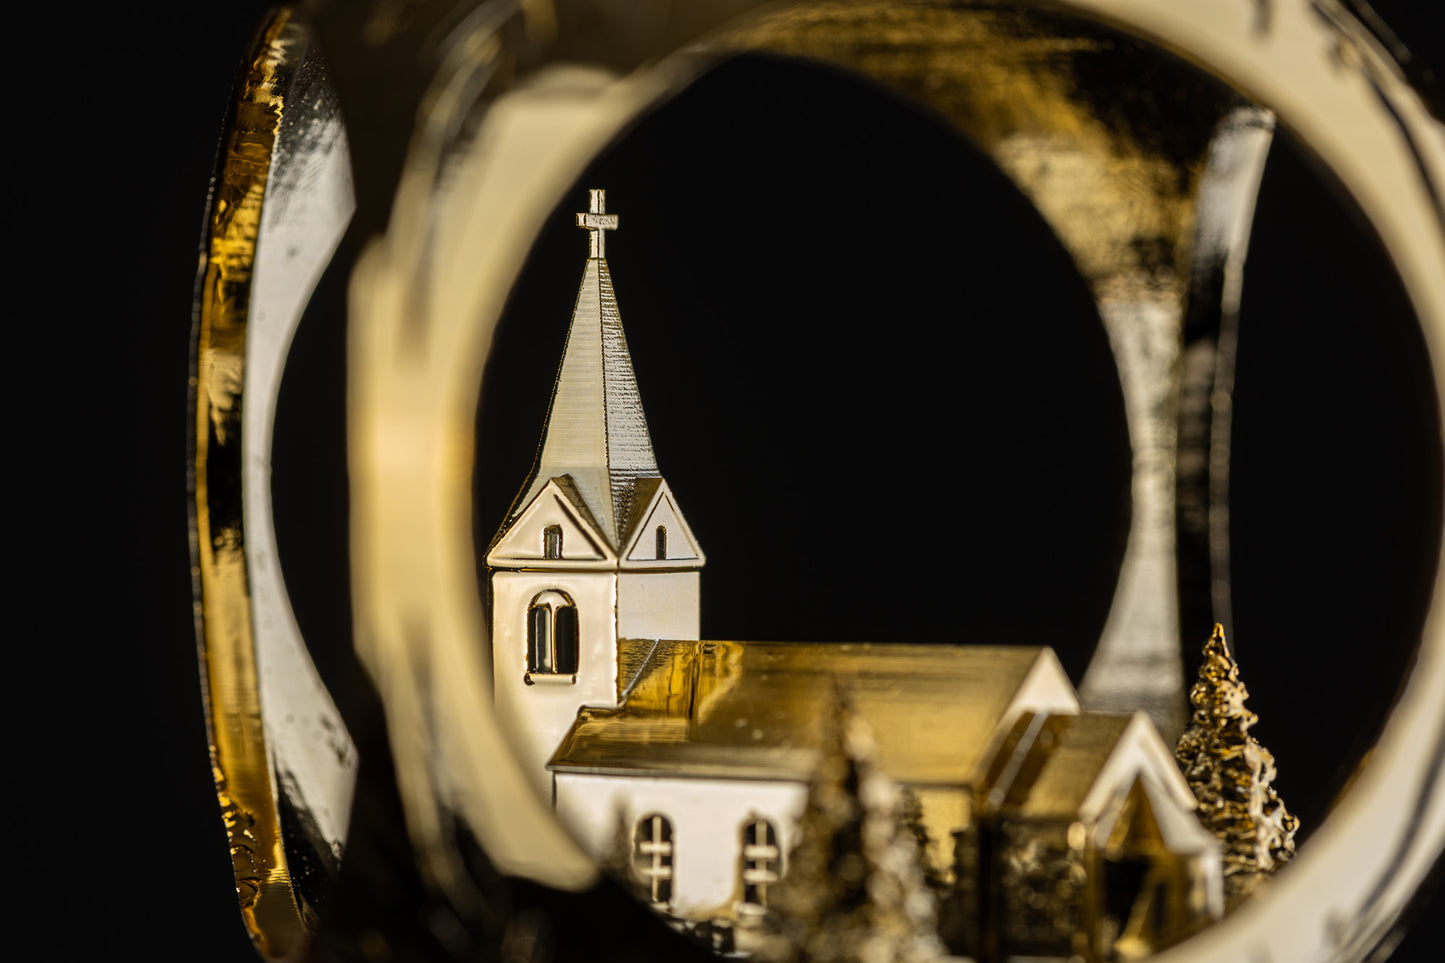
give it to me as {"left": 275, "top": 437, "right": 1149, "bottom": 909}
{"left": 503, "top": 191, "right": 657, "bottom": 549}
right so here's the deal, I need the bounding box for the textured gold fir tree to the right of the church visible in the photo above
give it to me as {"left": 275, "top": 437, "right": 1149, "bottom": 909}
{"left": 1175, "top": 625, "right": 1299, "bottom": 902}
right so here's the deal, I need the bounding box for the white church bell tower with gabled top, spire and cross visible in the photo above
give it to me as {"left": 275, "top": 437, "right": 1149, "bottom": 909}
{"left": 487, "top": 191, "right": 704, "bottom": 794}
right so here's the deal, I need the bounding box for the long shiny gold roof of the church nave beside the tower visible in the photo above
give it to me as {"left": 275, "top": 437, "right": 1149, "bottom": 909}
{"left": 549, "top": 639, "right": 1078, "bottom": 785}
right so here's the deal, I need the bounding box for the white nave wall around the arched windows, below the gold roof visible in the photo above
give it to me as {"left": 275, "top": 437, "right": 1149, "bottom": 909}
{"left": 556, "top": 772, "right": 808, "bottom": 920}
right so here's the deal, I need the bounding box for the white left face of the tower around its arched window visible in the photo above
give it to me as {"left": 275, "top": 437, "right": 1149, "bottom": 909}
{"left": 491, "top": 571, "right": 617, "bottom": 798}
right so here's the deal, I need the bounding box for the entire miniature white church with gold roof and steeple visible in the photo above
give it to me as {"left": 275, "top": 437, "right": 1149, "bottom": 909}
{"left": 487, "top": 191, "right": 1222, "bottom": 960}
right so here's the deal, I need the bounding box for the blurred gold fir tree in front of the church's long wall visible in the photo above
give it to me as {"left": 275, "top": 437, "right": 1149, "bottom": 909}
{"left": 757, "top": 697, "right": 944, "bottom": 963}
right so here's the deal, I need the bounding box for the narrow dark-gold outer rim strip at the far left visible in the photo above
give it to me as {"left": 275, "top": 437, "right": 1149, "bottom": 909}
{"left": 189, "top": 9, "right": 308, "bottom": 959}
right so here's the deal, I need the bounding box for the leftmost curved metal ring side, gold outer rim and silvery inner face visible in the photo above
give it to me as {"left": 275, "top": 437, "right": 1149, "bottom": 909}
{"left": 188, "top": 7, "right": 355, "bottom": 959}
